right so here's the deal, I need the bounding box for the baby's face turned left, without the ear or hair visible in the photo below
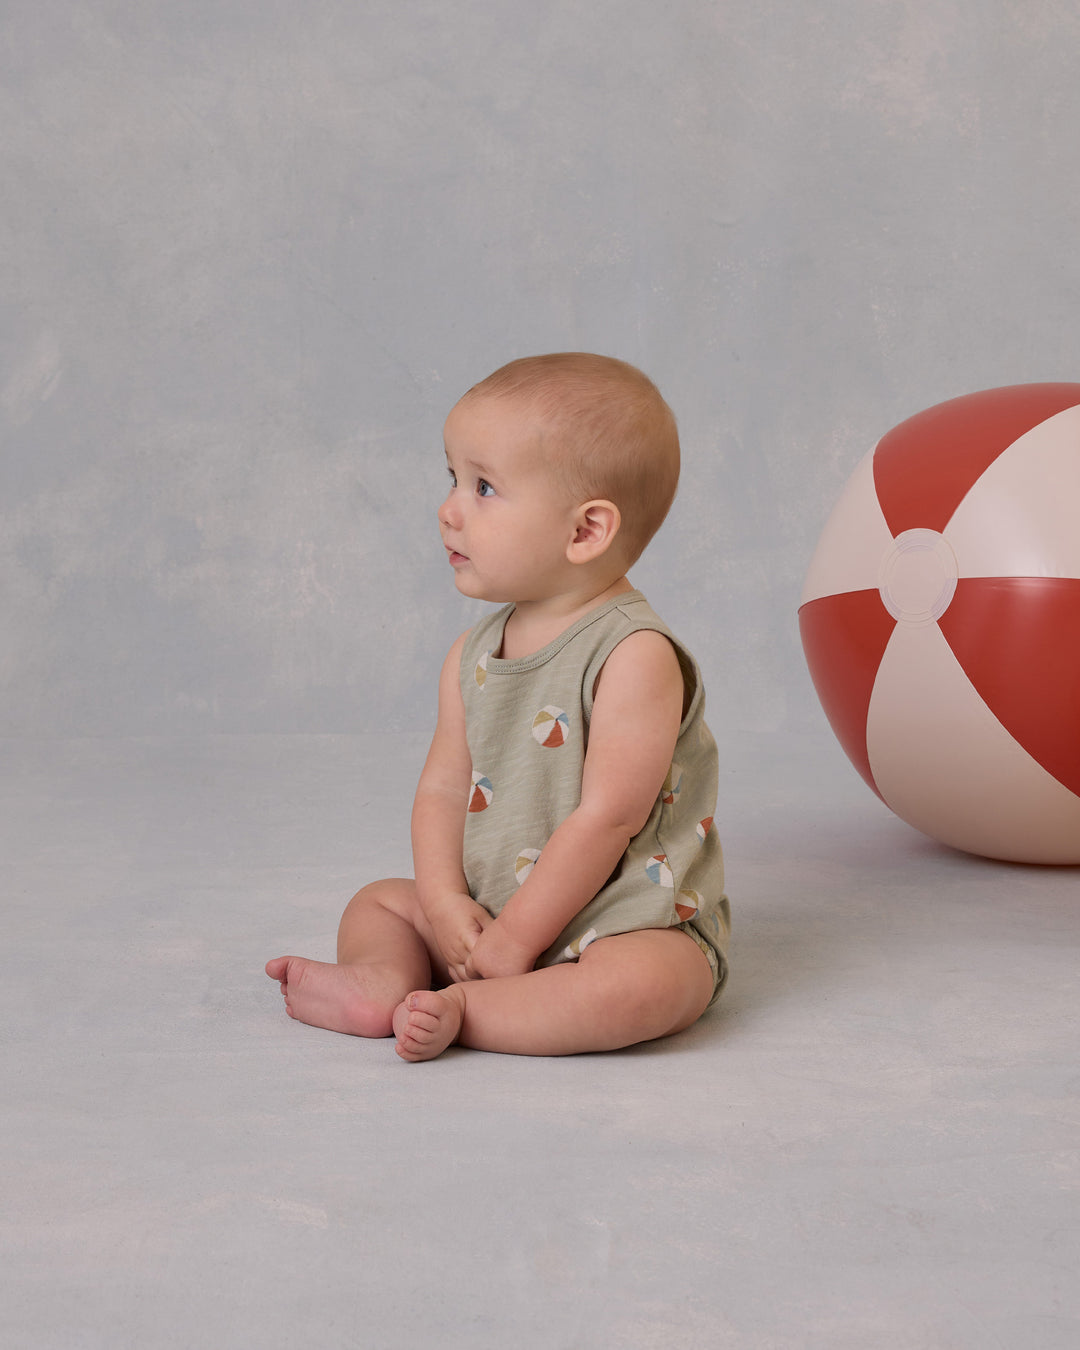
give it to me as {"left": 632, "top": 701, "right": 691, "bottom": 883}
{"left": 439, "top": 396, "right": 576, "bottom": 603}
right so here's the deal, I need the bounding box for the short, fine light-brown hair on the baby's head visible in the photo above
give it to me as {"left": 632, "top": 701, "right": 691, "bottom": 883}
{"left": 463, "top": 351, "right": 679, "bottom": 567}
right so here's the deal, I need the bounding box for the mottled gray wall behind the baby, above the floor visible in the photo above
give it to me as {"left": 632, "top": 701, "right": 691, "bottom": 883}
{"left": 0, "top": 0, "right": 1080, "bottom": 734}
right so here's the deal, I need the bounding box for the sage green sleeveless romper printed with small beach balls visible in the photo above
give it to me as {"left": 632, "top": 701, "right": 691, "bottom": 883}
{"left": 460, "top": 591, "right": 730, "bottom": 998}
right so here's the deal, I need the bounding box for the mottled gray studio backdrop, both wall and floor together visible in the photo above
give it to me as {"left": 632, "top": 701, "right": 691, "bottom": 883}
{"left": 8, "top": 13, "right": 1080, "bottom": 1350}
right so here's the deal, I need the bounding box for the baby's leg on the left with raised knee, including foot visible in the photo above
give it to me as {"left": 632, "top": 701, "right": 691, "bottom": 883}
{"left": 266, "top": 880, "right": 447, "bottom": 1037}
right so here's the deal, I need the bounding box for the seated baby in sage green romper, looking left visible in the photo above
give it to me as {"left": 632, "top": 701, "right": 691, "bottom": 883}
{"left": 266, "top": 352, "right": 729, "bottom": 1060}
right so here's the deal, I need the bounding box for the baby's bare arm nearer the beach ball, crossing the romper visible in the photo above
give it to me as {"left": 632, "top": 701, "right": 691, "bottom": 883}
{"left": 466, "top": 632, "right": 683, "bottom": 977}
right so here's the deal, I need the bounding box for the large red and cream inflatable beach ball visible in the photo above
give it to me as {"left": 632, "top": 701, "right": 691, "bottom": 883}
{"left": 799, "top": 385, "right": 1080, "bottom": 864}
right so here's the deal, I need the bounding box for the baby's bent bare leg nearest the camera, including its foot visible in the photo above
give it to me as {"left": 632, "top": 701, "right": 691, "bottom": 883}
{"left": 394, "top": 929, "right": 713, "bottom": 1060}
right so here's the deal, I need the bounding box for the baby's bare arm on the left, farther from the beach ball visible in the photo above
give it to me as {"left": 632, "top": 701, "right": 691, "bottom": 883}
{"left": 412, "top": 635, "right": 491, "bottom": 980}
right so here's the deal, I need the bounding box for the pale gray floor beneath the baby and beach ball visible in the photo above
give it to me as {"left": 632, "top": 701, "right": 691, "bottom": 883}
{"left": 0, "top": 736, "right": 1080, "bottom": 1350}
